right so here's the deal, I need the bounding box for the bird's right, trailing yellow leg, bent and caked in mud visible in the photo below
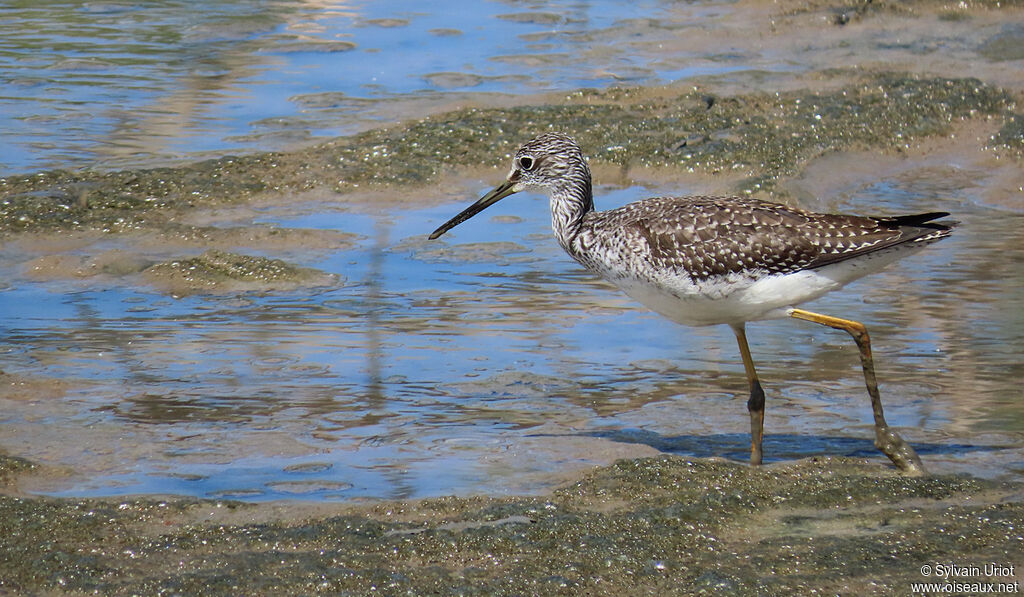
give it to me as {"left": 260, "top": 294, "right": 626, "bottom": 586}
{"left": 788, "top": 309, "right": 925, "bottom": 474}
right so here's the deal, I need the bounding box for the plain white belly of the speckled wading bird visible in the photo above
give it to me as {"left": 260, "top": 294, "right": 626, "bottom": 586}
{"left": 612, "top": 270, "right": 843, "bottom": 326}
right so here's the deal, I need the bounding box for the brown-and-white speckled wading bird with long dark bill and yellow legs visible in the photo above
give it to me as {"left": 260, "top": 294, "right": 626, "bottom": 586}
{"left": 428, "top": 132, "right": 956, "bottom": 474}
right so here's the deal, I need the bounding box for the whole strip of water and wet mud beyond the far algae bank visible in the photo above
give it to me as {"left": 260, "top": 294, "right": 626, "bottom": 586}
{"left": 0, "top": 0, "right": 1021, "bottom": 176}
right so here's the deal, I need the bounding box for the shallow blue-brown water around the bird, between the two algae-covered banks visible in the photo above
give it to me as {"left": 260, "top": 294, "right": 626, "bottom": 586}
{"left": 0, "top": 174, "right": 1024, "bottom": 499}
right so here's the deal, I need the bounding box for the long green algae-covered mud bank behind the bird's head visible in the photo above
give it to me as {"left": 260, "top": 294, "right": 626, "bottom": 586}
{"left": 0, "top": 73, "right": 1022, "bottom": 233}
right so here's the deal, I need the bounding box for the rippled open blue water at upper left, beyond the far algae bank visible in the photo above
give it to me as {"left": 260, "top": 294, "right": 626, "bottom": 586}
{"left": 0, "top": 0, "right": 751, "bottom": 175}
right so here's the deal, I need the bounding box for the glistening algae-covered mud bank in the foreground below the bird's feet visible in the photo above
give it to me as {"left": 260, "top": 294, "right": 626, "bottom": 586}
{"left": 0, "top": 457, "right": 1024, "bottom": 595}
